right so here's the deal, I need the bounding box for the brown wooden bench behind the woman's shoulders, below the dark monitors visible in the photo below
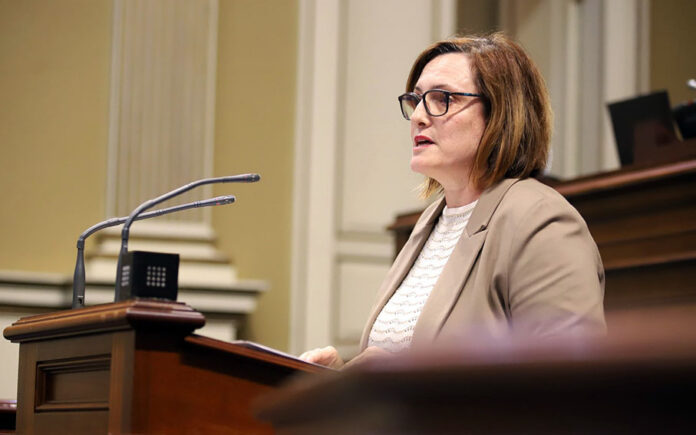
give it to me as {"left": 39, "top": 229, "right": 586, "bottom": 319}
{"left": 389, "top": 155, "right": 696, "bottom": 310}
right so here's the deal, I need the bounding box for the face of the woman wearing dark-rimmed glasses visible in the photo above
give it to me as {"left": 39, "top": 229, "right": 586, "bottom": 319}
{"left": 411, "top": 53, "right": 486, "bottom": 190}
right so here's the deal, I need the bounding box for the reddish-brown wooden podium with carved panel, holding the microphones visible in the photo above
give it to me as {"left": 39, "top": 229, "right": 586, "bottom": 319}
{"left": 4, "top": 299, "right": 322, "bottom": 434}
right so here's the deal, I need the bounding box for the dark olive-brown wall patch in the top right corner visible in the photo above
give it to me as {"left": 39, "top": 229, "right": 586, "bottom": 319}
{"left": 650, "top": 0, "right": 696, "bottom": 106}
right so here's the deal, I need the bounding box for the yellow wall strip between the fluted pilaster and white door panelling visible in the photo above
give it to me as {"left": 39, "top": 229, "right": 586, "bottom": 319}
{"left": 213, "top": 0, "right": 297, "bottom": 349}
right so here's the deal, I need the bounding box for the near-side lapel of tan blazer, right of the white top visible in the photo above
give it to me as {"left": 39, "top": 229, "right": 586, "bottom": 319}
{"left": 410, "top": 179, "right": 518, "bottom": 345}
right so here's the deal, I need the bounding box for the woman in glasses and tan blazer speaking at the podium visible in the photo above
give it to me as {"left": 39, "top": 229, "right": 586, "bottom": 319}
{"left": 301, "top": 33, "right": 605, "bottom": 368}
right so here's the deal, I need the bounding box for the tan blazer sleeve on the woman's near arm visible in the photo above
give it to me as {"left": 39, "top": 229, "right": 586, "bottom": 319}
{"left": 506, "top": 197, "right": 606, "bottom": 336}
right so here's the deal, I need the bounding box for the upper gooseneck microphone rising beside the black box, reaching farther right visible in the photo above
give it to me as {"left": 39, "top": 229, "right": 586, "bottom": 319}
{"left": 114, "top": 174, "right": 261, "bottom": 302}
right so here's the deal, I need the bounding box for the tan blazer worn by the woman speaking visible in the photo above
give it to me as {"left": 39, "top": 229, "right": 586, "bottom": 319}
{"left": 361, "top": 179, "right": 606, "bottom": 349}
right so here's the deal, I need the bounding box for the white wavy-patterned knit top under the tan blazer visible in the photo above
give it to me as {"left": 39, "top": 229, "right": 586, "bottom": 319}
{"left": 368, "top": 201, "right": 477, "bottom": 352}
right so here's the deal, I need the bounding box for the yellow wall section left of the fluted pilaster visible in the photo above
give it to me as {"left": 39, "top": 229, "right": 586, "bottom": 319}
{"left": 0, "top": 0, "right": 111, "bottom": 273}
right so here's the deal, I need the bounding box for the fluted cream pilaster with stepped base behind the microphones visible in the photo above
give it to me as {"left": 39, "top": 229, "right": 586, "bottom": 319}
{"left": 86, "top": 0, "right": 266, "bottom": 328}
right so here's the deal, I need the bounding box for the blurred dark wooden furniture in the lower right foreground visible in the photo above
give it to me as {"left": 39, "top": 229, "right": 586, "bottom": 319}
{"left": 259, "top": 307, "right": 696, "bottom": 435}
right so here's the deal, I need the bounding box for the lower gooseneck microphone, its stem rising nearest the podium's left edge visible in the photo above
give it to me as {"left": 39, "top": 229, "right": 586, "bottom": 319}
{"left": 72, "top": 195, "right": 236, "bottom": 309}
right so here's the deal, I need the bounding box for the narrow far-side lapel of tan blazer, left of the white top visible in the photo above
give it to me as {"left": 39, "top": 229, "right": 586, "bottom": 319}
{"left": 360, "top": 198, "right": 445, "bottom": 349}
